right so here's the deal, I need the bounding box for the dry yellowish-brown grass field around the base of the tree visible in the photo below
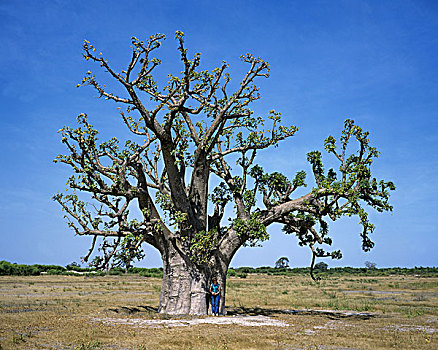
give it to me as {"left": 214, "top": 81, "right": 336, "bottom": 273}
{"left": 0, "top": 274, "right": 438, "bottom": 350}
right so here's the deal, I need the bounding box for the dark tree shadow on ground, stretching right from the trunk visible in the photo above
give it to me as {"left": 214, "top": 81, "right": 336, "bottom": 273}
{"left": 227, "top": 307, "right": 381, "bottom": 320}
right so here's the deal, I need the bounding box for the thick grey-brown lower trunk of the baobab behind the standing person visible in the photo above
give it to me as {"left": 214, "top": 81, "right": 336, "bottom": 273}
{"left": 159, "top": 243, "right": 228, "bottom": 315}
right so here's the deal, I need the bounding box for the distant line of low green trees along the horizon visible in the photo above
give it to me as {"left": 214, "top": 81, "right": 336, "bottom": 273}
{"left": 0, "top": 260, "right": 438, "bottom": 278}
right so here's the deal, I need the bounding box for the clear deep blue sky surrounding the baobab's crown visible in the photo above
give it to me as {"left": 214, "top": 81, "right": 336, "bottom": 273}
{"left": 0, "top": 0, "right": 438, "bottom": 267}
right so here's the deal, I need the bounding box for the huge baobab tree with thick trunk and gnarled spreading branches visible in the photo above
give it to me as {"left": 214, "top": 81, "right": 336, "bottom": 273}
{"left": 54, "top": 31, "right": 394, "bottom": 314}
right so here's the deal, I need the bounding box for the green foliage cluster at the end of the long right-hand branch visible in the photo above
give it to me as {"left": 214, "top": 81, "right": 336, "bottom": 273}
{"left": 283, "top": 119, "right": 395, "bottom": 266}
